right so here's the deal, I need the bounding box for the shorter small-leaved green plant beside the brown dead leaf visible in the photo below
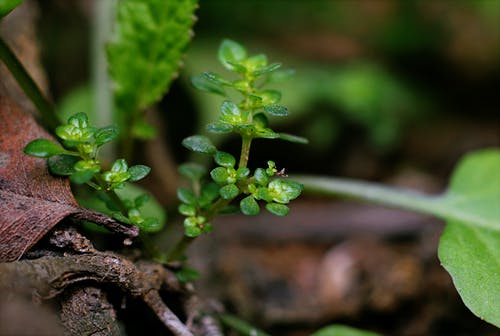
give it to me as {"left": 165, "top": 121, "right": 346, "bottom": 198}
{"left": 24, "top": 112, "right": 159, "bottom": 231}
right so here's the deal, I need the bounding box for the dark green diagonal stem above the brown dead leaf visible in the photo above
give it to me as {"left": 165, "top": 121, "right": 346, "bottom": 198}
{"left": 0, "top": 38, "right": 60, "bottom": 130}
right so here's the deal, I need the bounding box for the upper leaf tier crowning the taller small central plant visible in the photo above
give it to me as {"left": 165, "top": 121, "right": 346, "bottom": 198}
{"left": 191, "top": 39, "right": 307, "bottom": 143}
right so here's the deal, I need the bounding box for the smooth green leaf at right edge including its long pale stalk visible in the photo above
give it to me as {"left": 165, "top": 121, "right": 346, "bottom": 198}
{"left": 295, "top": 149, "right": 500, "bottom": 327}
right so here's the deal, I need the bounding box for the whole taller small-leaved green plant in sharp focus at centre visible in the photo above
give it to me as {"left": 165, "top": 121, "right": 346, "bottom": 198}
{"left": 167, "top": 40, "right": 307, "bottom": 261}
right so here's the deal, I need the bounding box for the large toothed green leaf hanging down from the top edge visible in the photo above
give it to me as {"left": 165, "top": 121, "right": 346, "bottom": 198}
{"left": 107, "top": 0, "right": 198, "bottom": 112}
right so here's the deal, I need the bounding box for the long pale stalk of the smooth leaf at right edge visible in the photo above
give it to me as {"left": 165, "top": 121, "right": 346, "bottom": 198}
{"left": 293, "top": 175, "right": 441, "bottom": 215}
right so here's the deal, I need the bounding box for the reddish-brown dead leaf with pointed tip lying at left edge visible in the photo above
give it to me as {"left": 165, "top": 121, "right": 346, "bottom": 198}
{"left": 0, "top": 96, "right": 138, "bottom": 262}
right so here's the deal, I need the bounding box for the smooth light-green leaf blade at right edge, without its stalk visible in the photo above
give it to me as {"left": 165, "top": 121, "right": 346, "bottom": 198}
{"left": 439, "top": 150, "right": 500, "bottom": 327}
